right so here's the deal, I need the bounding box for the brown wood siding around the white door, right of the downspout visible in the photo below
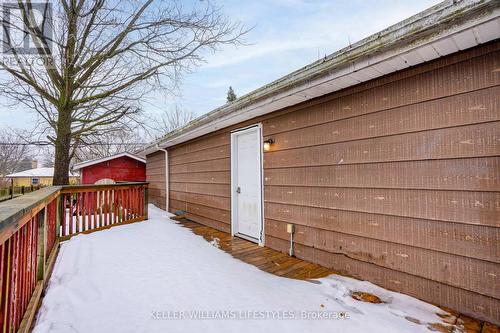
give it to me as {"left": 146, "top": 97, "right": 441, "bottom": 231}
{"left": 165, "top": 42, "right": 500, "bottom": 324}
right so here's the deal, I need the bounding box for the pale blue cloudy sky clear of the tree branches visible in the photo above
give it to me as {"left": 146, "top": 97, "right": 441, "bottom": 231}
{"left": 0, "top": 0, "right": 439, "bottom": 134}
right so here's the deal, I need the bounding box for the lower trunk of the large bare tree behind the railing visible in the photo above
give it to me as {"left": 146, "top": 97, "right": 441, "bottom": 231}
{"left": 53, "top": 109, "right": 71, "bottom": 185}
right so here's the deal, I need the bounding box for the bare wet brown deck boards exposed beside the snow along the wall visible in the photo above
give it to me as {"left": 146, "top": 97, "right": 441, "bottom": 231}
{"left": 173, "top": 217, "right": 500, "bottom": 333}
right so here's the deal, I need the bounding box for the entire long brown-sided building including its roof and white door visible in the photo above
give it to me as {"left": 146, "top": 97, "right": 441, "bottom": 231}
{"left": 140, "top": 1, "right": 500, "bottom": 323}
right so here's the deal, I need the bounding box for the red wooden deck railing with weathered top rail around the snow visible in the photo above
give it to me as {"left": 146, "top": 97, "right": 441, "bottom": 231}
{"left": 0, "top": 183, "right": 147, "bottom": 333}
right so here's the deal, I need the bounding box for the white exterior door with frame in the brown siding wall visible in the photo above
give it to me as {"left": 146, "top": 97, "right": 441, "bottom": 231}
{"left": 231, "top": 126, "right": 262, "bottom": 243}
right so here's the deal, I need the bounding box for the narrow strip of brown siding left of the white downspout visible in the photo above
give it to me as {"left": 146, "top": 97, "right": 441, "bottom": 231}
{"left": 146, "top": 151, "right": 167, "bottom": 209}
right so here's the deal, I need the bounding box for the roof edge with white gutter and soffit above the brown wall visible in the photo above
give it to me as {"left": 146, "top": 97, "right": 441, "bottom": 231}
{"left": 142, "top": 0, "right": 500, "bottom": 154}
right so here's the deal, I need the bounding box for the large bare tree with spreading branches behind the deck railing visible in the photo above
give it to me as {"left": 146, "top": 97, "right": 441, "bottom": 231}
{"left": 0, "top": 0, "right": 246, "bottom": 185}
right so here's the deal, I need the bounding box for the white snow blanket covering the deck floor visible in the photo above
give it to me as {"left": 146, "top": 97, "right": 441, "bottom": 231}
{"left": 34, "top": 206, "right": 458, "bottom": 333}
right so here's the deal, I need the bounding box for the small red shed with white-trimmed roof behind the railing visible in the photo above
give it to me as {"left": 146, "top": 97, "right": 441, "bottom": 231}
{"left": 73, "top": 152, "right": 146, "bottom": 184}
